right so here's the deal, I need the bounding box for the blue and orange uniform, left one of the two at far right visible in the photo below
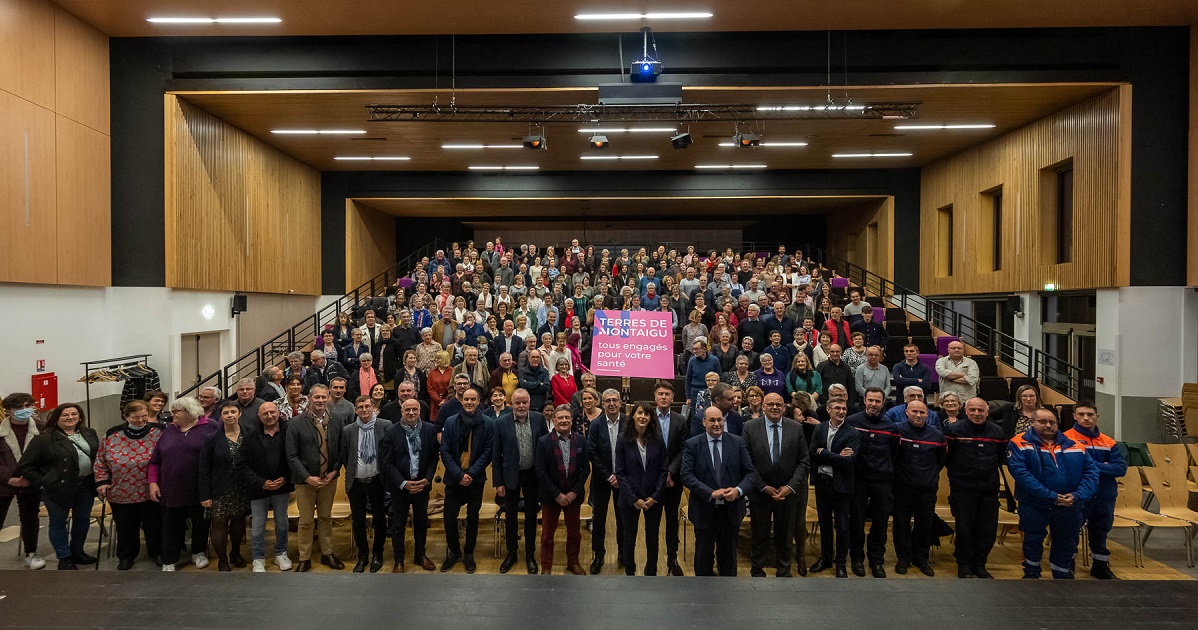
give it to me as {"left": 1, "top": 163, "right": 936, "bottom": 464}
{"left": 1006, "top": 429, "right": 1099, "bottom": 578}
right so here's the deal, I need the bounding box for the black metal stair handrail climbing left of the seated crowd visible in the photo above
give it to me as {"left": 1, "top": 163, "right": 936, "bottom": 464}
{"left": 179, "top": 238, "right": 449, "bottom": 396}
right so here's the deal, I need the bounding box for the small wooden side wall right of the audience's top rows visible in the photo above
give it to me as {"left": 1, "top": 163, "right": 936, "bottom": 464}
{"left": 828, "top": 196, "right": 895, "bottom": 278}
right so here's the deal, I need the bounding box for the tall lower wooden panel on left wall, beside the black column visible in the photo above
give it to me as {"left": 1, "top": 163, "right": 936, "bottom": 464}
{"left": 55, "top": 115, "right": 110, "bottom": 286}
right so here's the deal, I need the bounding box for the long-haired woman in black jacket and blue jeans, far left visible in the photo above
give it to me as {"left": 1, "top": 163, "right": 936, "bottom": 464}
{"left": 8, "top": 402, "right": 99, "bottom": 570}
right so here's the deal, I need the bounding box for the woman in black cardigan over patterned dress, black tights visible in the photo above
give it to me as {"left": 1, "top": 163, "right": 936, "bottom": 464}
{"left": 199, "top": 400, "right": 249, "bottom": 571}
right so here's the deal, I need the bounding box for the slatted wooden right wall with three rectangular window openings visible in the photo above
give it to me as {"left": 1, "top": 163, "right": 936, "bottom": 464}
{"left": 919, "top": 89, "right": 1130, "bottom": 295}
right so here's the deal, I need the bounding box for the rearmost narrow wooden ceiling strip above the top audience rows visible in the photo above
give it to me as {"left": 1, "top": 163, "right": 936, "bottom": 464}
{"left": 355, "top": 195, "right": 885, "bottom": 219}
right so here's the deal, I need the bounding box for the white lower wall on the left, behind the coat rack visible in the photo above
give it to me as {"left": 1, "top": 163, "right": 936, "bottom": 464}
{"left": 0, "top": 283, "right": 339, "bottom": 416}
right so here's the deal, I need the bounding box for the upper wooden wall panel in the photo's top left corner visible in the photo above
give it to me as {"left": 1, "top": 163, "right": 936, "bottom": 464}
{"left": 0, "top": 0, "right": 56, "bottom": 110}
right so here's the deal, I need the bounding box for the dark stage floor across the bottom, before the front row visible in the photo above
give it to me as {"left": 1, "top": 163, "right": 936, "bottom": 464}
{"left": 0, "top": 570, "right": 1198, "bottom": 630}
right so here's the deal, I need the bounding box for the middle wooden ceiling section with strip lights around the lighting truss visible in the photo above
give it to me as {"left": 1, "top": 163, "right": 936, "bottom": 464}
{"left": 181, "top": 84, "right": 1113, "bottom": 171}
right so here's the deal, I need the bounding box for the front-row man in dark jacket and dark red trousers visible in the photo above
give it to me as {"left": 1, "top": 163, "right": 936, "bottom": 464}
{"left": 536, "top": 405, "right": 591, "bottom": 575}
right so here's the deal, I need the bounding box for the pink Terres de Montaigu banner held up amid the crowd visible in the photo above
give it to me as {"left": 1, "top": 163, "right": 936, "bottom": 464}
{"left": 591, "top": 310, "right": 673, "bottom": 378}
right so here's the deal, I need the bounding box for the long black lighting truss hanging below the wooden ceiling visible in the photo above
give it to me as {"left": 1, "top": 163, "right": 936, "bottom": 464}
{"left": 367, "top": 102, "right": 922, "bottom": 125}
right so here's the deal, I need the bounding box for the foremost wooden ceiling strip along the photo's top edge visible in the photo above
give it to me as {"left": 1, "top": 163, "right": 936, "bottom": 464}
{"left": 55, "top": 0, "right": 1198, "bottom": 37}
